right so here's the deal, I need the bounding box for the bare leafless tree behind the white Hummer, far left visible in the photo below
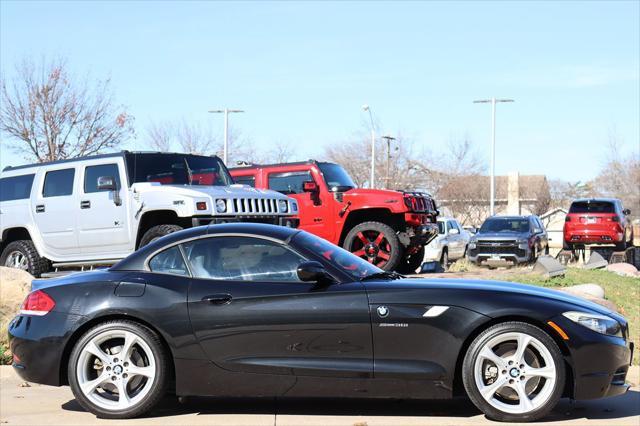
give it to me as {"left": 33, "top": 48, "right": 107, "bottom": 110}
{"left": 0, "top": 60, "right": 134, "bottom": 162}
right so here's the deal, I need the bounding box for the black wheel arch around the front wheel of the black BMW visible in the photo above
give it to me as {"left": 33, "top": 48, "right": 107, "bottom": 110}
{"left": 452, "top": 315, "right": 574, "bottom": 397}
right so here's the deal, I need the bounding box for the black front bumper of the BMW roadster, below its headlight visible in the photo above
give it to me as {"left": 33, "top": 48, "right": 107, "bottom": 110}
{"left": 552, "top": 316, "right": 634, "bottom": 400}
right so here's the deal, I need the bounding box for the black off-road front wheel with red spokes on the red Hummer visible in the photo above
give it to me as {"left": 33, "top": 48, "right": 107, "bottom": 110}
{"left": 343, "top": 222, "right": 403, "bottom": 271}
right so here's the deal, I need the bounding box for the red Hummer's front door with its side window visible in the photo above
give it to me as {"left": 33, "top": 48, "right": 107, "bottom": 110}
{"left": 267, "top": 169, "right": 335, "bottom": 241}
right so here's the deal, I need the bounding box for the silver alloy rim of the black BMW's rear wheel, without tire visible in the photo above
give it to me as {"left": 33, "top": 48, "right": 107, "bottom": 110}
{"left": 76, "top": 330, "right": 156, "bottom": 411}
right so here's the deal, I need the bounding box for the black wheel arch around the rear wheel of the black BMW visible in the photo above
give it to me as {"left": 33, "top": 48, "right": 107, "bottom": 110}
{"left": 59, "top": 314, "right": 176, "bottom": 391}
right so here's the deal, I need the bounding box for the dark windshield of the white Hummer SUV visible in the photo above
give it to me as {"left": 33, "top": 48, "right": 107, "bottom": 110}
{"left": 127, "top": 153, "right": 233, "bottom": 186}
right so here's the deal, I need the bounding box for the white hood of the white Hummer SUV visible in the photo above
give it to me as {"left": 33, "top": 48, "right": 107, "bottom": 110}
{"left": 132, "top": 183, "right": 287, "bottom": 200}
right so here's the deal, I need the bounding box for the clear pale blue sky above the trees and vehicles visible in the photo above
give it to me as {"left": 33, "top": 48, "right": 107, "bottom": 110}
{"left": 0, "top": 0, "right": 640, "bottom": 181}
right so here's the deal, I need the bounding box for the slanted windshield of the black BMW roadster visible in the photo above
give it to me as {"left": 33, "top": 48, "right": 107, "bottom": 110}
{"left": 293, "top": 231, "right": 382, "bottom": 280}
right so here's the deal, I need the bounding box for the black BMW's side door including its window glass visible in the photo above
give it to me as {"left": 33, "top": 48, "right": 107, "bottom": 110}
{"left": 182, "top": 236, "right": 373, "bottom": 385}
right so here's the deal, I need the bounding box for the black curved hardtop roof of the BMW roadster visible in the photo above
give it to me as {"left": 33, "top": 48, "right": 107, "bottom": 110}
{"left": 110, "top": 222, "right": 300, "bottom": 271}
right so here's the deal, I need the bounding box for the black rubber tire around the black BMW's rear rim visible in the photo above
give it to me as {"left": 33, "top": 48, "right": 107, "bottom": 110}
{"left": 67, "top": 320, "right": 170, "bottom": 419}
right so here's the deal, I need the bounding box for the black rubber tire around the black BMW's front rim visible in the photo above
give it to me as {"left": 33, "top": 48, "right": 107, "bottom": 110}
{"left": 462, "top": 321, "right": 566, "bottom": 422}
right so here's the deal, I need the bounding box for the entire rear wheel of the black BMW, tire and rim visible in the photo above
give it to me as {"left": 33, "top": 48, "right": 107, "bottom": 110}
{"left": 68, "top": 321, "right": 168, "bottom": 419}
